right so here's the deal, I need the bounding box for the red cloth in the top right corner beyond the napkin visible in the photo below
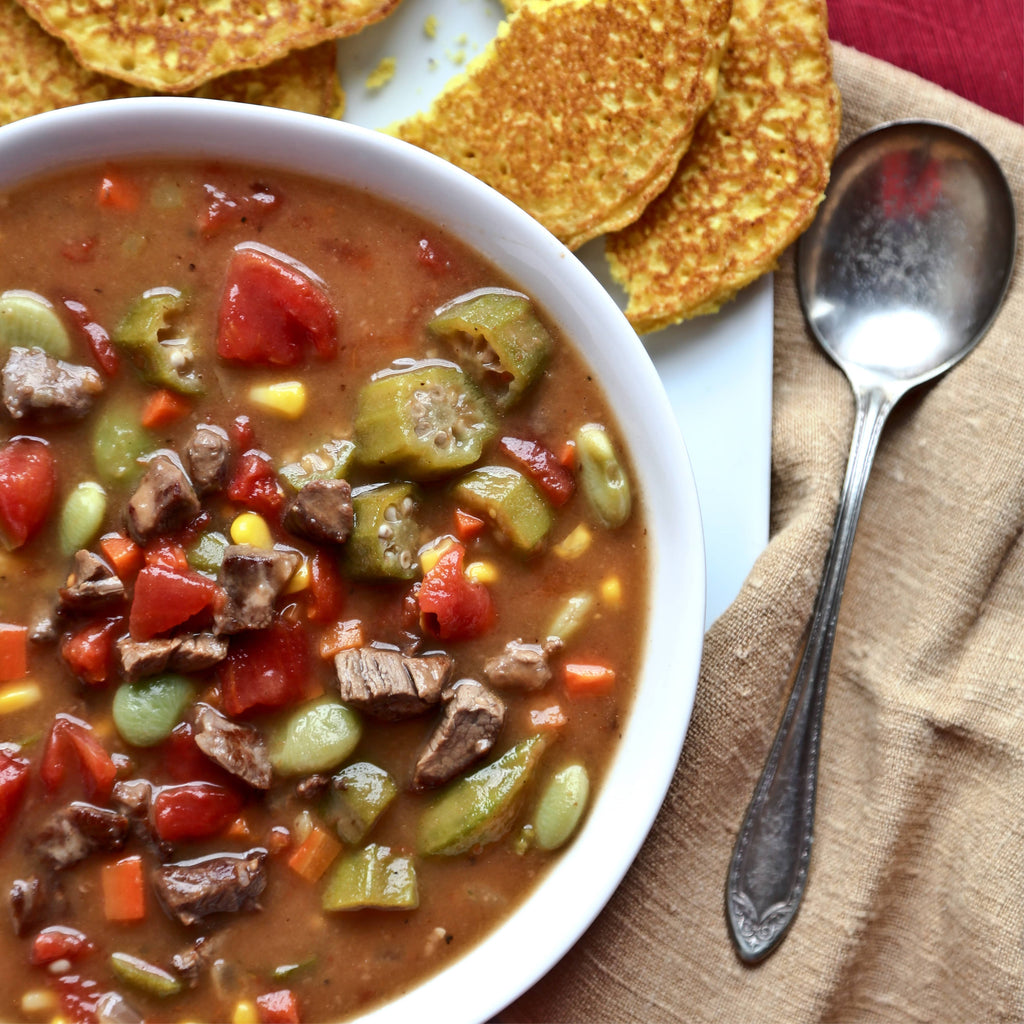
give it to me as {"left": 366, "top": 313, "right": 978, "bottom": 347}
{"left": 828, "top": 0, "right": 1024, "bottom": 123}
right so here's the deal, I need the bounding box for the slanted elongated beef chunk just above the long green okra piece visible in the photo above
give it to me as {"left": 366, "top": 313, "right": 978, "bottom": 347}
{"left": 413, "top": 679, "right": 505, "bottom": 790}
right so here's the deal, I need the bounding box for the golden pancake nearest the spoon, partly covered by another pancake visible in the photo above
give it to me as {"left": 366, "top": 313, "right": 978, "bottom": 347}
{"left": 605, "top": 0, "right": 840, "bottom": 333}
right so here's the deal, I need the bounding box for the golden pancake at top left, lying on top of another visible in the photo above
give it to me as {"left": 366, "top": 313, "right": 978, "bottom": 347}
{"left": 19, "top": 0, "right": 398, "bottom": 93}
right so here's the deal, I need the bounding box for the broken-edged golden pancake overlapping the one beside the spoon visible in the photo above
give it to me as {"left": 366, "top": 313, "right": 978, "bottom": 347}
{"left": 391, "top": 0, "right": 730, "bottom": 249}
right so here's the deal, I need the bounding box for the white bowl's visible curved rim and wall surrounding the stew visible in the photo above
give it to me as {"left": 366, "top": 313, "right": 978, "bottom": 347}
{"left": 0, "top": 97, "right": 705, "bottom": 1024}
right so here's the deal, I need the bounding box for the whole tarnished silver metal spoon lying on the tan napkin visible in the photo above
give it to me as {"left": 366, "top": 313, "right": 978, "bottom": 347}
{"left": 726, "top": 121, "right": 1016, "bottom": 963}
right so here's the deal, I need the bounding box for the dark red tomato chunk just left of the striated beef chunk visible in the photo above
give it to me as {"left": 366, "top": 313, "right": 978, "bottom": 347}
{"left": 225, "top": 620, "right": 309, "bottom": 715}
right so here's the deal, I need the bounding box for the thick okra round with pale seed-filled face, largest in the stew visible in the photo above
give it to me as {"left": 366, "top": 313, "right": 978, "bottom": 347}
{"left": 355, "top": 361, "right": 498, "bottom": 480}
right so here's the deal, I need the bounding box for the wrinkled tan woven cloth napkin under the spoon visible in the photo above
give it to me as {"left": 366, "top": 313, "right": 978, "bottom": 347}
{"left": 500, "top": 46, "right": 1024, "bottom": 1024}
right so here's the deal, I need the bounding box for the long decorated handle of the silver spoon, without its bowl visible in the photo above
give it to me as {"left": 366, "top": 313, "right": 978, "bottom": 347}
{"left": 726, "top": 387, "right": 896, "bottom": 963}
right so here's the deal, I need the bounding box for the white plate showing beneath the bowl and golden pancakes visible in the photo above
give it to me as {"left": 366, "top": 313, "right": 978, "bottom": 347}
{"left": 338, "top": 0, "right": 772, "bottom": 625}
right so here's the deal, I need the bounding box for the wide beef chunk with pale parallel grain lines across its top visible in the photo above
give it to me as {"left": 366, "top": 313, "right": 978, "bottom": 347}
{"left": 334, "top": 647, "right": 452, "bottom": 721}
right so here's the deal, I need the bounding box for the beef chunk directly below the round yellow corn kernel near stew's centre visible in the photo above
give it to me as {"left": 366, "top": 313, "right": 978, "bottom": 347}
{"left": 214, "top": 544, "right": 300, "bottom": 633}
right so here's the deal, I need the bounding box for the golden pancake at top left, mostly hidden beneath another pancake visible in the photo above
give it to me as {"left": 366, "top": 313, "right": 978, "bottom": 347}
{"left": 0, "top": 0, "right": 344, "bottom": 124}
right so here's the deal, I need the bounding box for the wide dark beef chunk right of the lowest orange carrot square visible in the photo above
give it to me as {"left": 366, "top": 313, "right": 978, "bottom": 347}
{"left": 153, "top": 849, "right": 266, "bottom": 925}
